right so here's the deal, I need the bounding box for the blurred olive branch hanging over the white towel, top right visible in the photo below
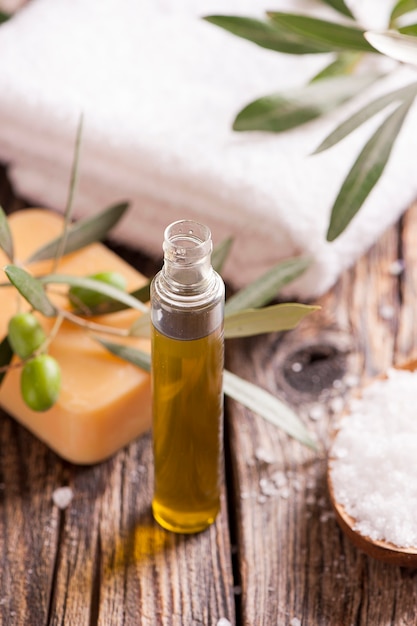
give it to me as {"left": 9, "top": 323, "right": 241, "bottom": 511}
{"left": 204, "top": 0, "right": 417, "bottom": 241}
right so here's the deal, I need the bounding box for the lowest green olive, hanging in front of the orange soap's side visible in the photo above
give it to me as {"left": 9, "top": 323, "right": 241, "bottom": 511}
{"left": 20, "top": 354, "right": 61, "bottom": 411}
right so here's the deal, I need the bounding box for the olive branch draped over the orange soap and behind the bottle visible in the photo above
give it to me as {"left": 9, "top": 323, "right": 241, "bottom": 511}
{"left": 0, "top": 118, "right": 320, "bottom": 449}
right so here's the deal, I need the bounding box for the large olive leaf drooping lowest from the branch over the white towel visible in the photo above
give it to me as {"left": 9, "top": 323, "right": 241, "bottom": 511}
{"left": 327, "top": 98, "right": 413, "bottom": 241}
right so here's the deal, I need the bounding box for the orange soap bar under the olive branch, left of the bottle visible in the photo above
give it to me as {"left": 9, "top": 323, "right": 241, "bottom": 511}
{"left": 0, "top": 209, "right": 151, "bottom": 464}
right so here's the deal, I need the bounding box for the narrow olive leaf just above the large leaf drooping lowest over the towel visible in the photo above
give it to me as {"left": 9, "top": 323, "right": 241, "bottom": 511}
{"left": 312, "top": 82, "right": 417, "bottom": 154}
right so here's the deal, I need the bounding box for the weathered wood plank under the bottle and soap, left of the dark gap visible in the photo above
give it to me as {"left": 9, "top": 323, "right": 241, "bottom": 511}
{"left": 0, "top": 414, "right": 234, "bottom": 626}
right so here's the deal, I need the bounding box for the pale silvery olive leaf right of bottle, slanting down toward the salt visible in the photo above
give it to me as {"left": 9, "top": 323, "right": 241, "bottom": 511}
{"left": 223, "top": 370, "right": 317, "bottom": 450}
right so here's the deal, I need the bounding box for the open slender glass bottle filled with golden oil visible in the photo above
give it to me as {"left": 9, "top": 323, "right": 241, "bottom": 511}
{"left": 151, "top": 220, "right": 224, "bottom": 533}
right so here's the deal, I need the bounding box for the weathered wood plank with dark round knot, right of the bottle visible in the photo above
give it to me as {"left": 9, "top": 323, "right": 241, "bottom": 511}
{"left": 228, "top": 217, "right": 417, "bottom": 626}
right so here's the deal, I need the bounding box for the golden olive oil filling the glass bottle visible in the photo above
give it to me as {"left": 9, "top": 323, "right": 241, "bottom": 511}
{"left": 152, "top": 329, "right": 223, "bottom": 532}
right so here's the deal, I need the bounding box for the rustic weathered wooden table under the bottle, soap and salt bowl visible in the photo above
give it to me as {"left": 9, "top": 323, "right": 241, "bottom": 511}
{"left": 0, "top": 166, "right": 417, "bottom": 626}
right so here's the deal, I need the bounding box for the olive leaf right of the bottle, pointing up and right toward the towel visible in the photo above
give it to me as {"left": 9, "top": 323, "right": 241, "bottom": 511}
{"left": 225, "top": 257, "right": 311, "bottom": 317}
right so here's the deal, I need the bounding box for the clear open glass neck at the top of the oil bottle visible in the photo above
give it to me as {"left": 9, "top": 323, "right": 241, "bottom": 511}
{"left": 162, "top": 220, "right": 213, "bottom": 293}
